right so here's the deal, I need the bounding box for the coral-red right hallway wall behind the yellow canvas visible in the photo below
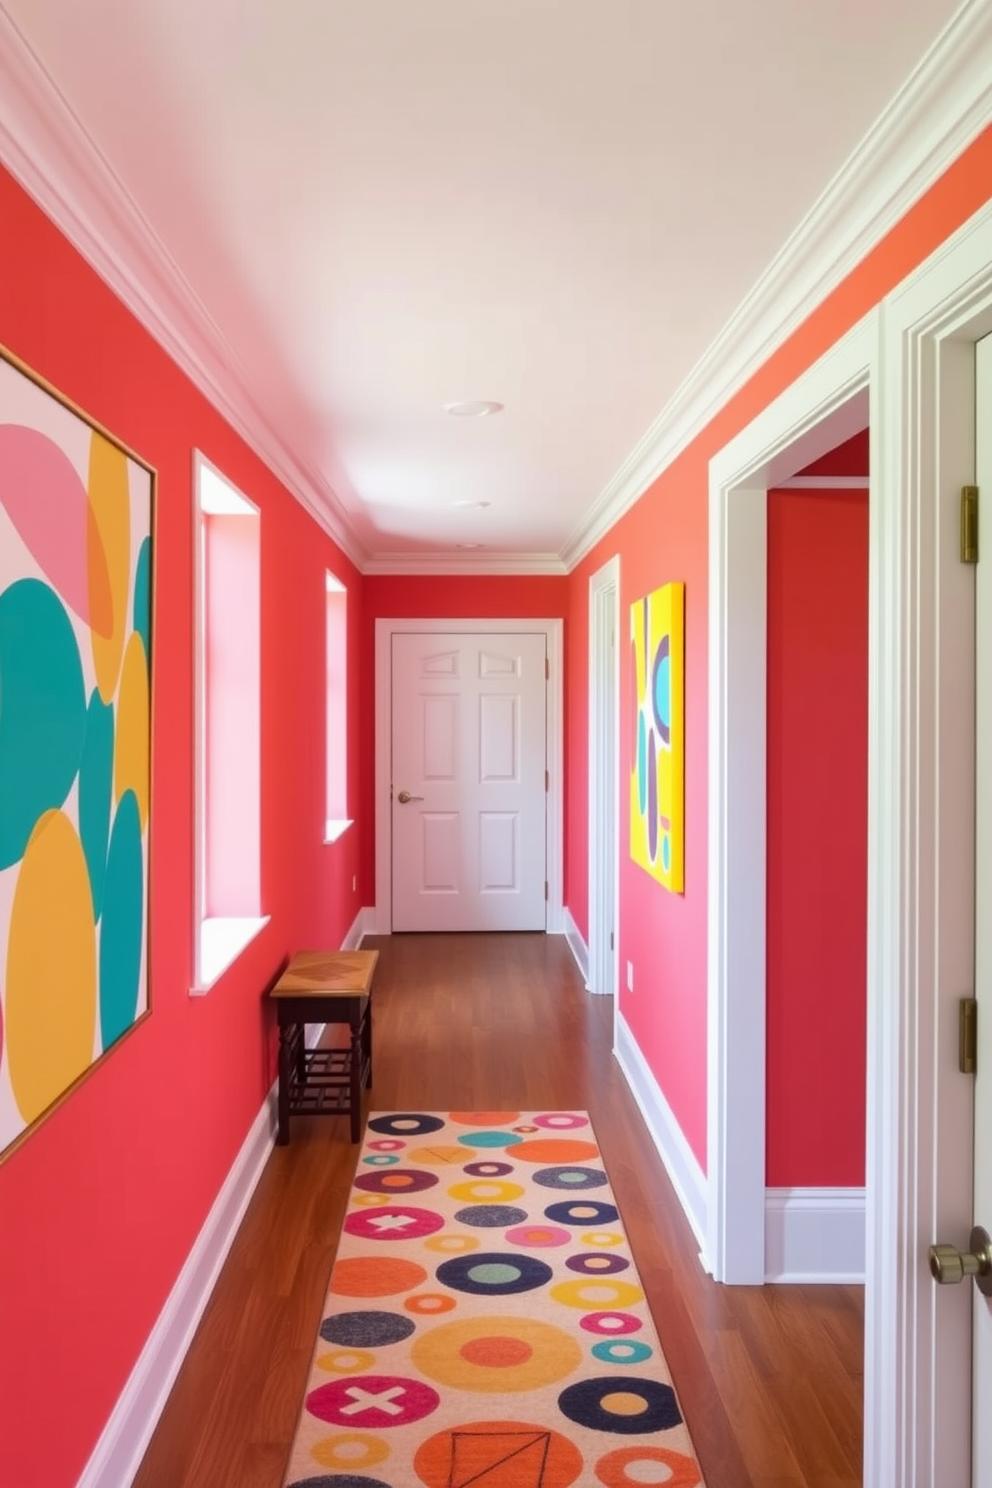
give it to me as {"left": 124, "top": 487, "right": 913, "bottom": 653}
{"left": 567, "top": 129, "right": 992, "bottom": 1183}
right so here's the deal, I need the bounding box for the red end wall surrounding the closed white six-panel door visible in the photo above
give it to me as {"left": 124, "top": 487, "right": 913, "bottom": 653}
{"left": 360, "top": 574, "right": 571, "bottom": 905}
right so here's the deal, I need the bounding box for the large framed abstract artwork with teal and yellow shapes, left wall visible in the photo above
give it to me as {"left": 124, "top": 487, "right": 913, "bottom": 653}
{"left": 0, "top": 353, "right": 155, "bottom": 1156}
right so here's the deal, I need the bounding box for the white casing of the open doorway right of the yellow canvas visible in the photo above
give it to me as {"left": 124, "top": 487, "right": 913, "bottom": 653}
{"left": 703, "top": 315, "right": 877, "bottom": 1286}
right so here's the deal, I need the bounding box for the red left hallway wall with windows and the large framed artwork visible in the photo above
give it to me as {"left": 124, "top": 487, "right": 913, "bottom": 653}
{"left": 0, "top": 173, "right": 364, "bottom": 1488}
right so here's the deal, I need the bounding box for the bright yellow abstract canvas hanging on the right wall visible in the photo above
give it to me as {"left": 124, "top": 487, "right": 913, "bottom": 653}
{"left": 631, "top": 583, "right": 686, "bottom": 893}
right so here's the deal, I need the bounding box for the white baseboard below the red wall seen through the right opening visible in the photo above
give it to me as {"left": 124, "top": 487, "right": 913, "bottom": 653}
{"left": 764, "top": 1189, "right": 864, "bottom": 1283}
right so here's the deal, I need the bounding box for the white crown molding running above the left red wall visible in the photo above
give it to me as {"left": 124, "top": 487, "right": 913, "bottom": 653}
{"left": 0, "top": 6, "right": 366, "bottom": 568}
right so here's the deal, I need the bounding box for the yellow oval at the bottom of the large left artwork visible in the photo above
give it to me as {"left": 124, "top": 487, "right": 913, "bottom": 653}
{"left": 6, "top": 811, "right": 97, "bottom": 1125}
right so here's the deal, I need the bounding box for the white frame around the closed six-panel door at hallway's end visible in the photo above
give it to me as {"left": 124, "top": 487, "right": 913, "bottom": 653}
{"left": 372, "top": 618, "right": 565, "bottom": 934}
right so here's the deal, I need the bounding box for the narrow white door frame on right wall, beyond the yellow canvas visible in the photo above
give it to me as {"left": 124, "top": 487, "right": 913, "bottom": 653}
{"left": 586, "top": 554, "right": 620, "bottom": 995}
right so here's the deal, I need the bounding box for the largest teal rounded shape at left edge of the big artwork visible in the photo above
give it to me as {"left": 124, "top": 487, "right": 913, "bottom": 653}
{"left": 0, "top": 579, "right": 86, "bottom": 869}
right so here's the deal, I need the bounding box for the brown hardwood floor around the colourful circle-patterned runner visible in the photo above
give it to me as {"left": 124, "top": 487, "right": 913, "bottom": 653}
{"left": 135, "top": 934, "right": 864, "bottom": 1488}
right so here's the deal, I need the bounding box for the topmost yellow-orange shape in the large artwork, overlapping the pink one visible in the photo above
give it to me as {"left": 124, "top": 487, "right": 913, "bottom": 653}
{"left": 86, "top": 432, "right": 131, "bottom": 702}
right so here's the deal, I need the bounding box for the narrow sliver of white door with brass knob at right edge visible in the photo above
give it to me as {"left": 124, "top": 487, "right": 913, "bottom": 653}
{"left": 971, "top": 328, "right": 992, "bottom": 1488}
